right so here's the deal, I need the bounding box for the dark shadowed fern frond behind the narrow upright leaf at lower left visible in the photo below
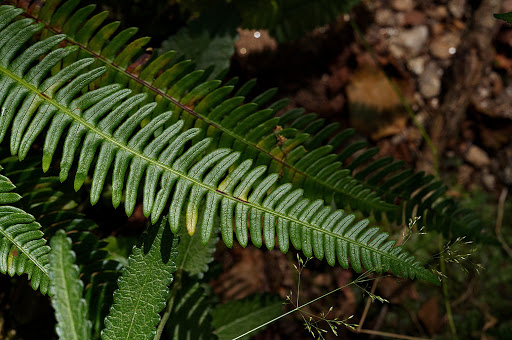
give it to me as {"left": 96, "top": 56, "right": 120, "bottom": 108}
{"left": 1, "top": 157, "right": 122, "bottom": 339}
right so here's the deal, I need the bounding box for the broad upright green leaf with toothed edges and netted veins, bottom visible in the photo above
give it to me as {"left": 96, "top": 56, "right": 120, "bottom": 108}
{"left": 101, "top": 220, "right": 178, "bottom": 339}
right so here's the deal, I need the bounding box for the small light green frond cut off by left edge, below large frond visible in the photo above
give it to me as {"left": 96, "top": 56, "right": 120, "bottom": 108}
{"left": 0, "top": 168, "right": 50, "bottom": 294}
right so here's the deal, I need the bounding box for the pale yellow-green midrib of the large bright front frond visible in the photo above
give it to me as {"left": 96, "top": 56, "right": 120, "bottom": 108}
{"left": 0, "top": 61, "right": 419, "bottom": 273}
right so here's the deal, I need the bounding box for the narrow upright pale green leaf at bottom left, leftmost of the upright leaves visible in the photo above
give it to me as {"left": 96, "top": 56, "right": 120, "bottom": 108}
{"left": 50, "top": 230, "right": 91, "bottom": 340}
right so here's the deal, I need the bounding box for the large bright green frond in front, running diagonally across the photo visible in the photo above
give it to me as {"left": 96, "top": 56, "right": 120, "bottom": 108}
{"left": 0, "top": 6, "right": 439, "bottom": 283}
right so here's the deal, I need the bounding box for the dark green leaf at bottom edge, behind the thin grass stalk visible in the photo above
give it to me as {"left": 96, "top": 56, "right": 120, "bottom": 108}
{"left": 212, "top": 295, "right": 283, "bottom": 340}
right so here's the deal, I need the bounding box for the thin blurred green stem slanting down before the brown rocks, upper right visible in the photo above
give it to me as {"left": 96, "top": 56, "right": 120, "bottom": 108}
{"left": 350, "top": 18, "right": 439, "bottom": 177}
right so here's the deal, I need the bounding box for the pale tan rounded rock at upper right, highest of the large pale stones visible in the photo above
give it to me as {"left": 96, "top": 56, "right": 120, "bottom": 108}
{"left": 390, "top": 25, "right": 428, "bottom": 57}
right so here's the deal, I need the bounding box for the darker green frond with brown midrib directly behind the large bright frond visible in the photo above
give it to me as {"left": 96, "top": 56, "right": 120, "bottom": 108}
{"left": 13, "top": 0, "right": 396, "bottom": 218}
